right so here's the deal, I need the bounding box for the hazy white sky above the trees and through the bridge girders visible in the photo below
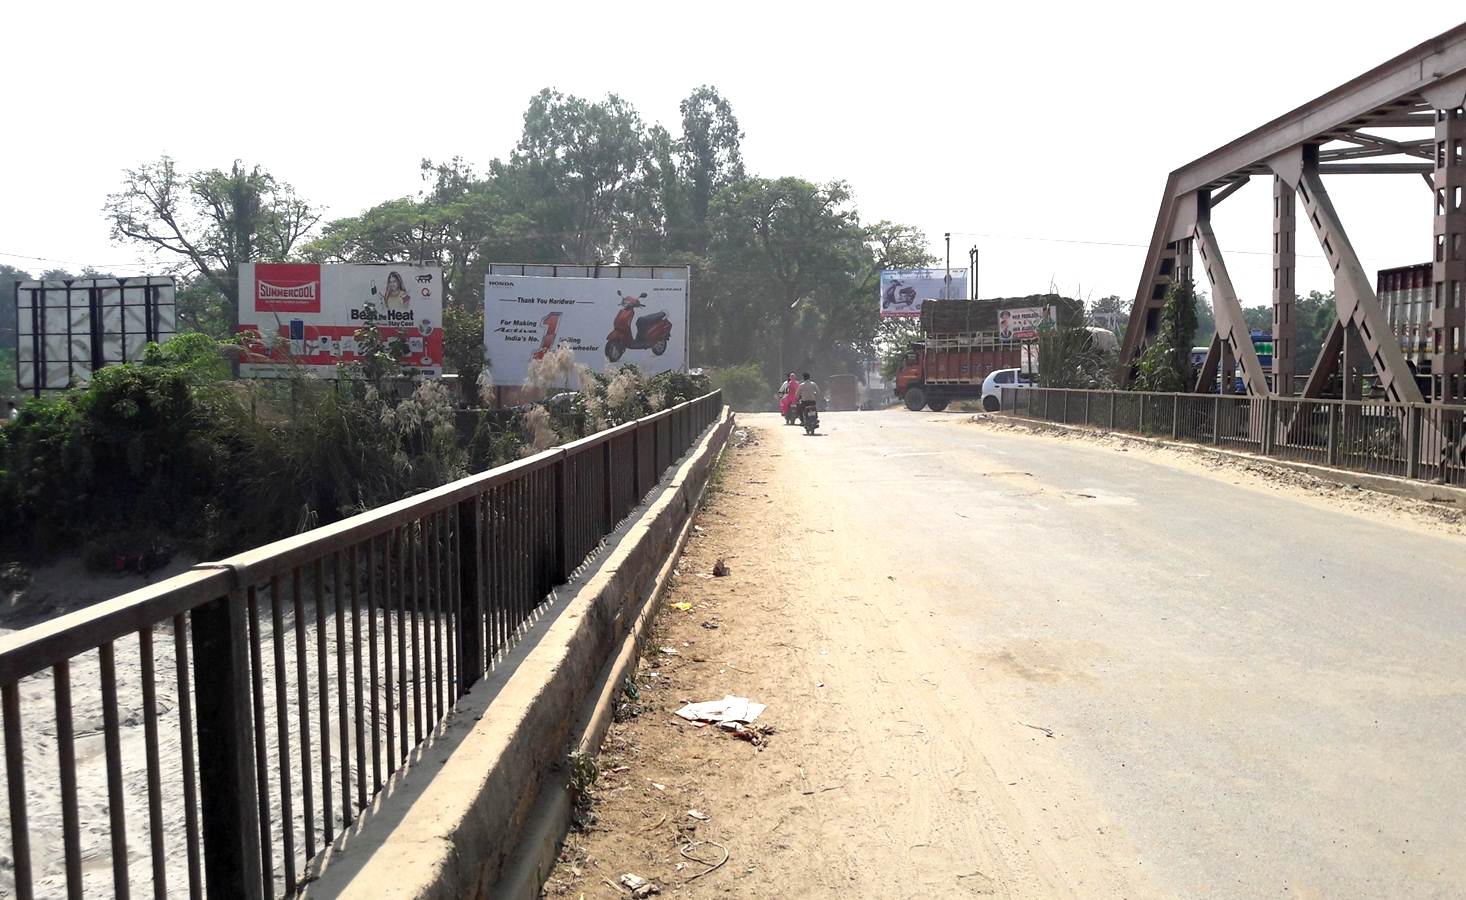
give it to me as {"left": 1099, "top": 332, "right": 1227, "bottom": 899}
{"left": 0, "top": 0, "right": 1459, "bottom": 303}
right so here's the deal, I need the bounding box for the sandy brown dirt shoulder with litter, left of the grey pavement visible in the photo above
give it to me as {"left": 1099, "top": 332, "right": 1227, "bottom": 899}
{"left": 544, "top": 427, "right": 1143, "bottom": 899}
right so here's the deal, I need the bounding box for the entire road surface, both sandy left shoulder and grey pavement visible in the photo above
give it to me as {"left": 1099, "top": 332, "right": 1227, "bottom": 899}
{"left": 545, "top": 410, "right": 1466, "bottom": 897}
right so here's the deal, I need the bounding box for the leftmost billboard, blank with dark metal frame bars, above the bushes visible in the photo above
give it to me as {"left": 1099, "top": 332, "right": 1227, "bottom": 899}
{"left": 15, "top": 276, "right": 176, "bottom": 396}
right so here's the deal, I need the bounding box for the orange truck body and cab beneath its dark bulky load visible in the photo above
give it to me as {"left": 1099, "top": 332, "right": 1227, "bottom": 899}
{"left": 896, "top": 331, "right": 1036, "bottom": 412}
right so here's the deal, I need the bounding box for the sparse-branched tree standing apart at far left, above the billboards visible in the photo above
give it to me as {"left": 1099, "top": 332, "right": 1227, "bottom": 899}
{"left": 103, "top": 157, "right": 320, "bottom": 331}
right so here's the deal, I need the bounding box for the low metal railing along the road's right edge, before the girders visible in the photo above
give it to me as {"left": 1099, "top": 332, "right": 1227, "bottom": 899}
{"left": 1000, "top": 387, "right": 1466, "bottom": 485}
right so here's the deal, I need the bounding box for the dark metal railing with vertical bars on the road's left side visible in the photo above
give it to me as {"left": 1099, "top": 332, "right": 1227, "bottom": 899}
{"left": 0, "top": 391, "right": 723, "bottom": 900}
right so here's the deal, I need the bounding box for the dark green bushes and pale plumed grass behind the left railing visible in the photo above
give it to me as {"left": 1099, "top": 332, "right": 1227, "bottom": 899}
{"left": 0, "top": 328, "right": 708, "bottom": 570}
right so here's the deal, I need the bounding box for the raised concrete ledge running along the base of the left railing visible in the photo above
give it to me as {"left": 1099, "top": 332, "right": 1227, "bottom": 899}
{"left": 313, "top": 410, "right": 733, "bottom": 900}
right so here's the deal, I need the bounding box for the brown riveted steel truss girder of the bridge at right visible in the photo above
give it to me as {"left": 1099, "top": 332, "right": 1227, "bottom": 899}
{"left": 1119, "top": 25, "right": 1466, "bottom": 402}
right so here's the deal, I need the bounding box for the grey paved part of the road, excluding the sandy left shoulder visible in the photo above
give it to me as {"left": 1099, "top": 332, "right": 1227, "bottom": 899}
{"left": 768, "top": 410, "right": 1466, "bottom": 897}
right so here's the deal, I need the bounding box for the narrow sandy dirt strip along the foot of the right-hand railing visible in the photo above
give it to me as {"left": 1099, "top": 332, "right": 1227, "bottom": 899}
{"left": 965, "top": 413, "right": 1466, "bottom": 535}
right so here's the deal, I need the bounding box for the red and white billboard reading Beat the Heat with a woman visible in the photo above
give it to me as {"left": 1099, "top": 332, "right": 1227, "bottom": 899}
{"left": 239, "top": 262, "right": 443, "bottom": 378}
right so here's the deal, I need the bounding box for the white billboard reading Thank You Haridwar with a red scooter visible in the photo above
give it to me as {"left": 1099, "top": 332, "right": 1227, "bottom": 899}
{"left": 484, "top": 267, "right": 688, "bottom": 384}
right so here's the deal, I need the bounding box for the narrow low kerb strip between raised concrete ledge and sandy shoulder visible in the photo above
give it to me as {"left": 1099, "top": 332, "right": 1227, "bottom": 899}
{"left": 488, "top": 412, "right": 733, "bottom": 900}
